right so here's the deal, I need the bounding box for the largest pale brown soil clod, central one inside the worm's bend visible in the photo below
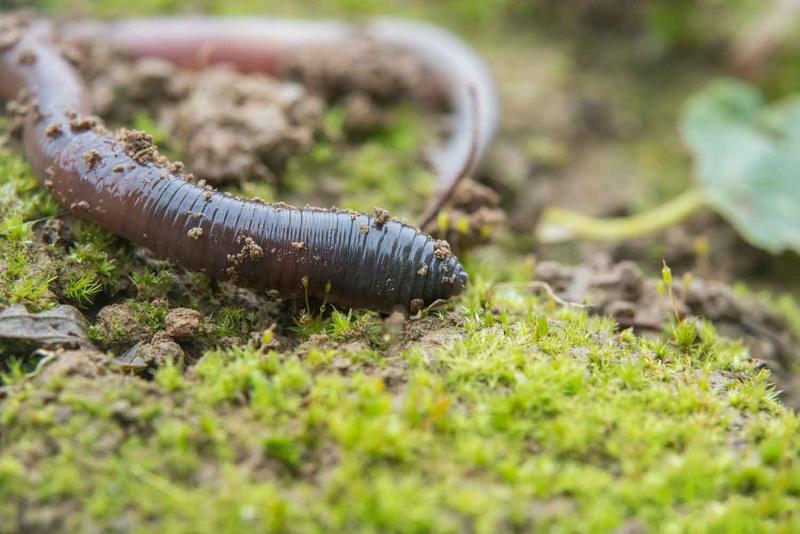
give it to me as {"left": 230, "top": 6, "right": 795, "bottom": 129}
{"left": 169, "top": 68, "right": 324, "bottom": 183}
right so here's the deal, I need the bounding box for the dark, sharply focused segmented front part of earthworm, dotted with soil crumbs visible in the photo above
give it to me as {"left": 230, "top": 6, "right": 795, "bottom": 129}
{"left": 0, "top": 17, "right": 468, "bottom": 312}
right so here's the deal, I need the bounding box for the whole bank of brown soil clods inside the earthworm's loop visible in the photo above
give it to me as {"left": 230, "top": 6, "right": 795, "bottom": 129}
{"left": 78, "top": 41, "right": 446, "bottom": 187}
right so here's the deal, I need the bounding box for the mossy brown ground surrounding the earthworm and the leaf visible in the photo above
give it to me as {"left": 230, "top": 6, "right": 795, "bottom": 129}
{"left": 0, "top": 0, "right": 800, "bottom": 532}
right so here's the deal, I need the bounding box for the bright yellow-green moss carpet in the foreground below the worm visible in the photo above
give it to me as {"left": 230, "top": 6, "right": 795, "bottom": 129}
{"left": 0, "top": 284, "right": 800, "bottom": 532}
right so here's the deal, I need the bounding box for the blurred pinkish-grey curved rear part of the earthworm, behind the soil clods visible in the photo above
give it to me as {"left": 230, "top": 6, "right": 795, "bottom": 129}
{"left": 62, "top": 17, "right": 499, "bottom": 227}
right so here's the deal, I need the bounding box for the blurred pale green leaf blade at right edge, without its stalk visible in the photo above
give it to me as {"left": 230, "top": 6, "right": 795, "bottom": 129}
{"left": 681, "top": 80, "right": 800, "bottom": 253}
